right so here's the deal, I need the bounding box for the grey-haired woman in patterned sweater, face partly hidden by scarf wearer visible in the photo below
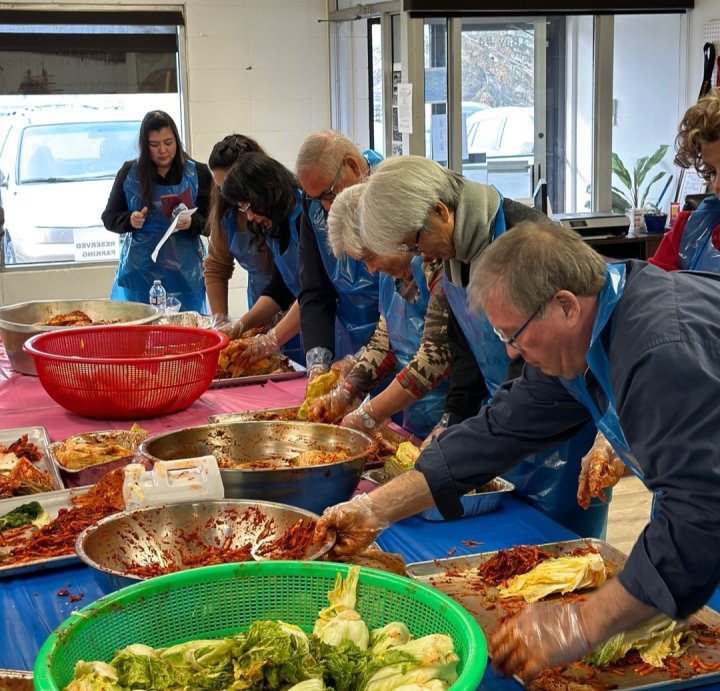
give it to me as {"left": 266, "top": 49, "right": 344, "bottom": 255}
{"left": 309, "top": 183, "right": 450, "bottom": 437}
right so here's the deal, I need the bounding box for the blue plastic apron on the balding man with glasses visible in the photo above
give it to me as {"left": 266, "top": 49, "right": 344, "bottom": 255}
{"left": 308, "top": 150, "right": 382, "bottom": 360}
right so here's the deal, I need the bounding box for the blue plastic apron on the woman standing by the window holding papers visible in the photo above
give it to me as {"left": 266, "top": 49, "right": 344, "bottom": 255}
{"left": 110, "top": 161, "right": 207, "bottom": 313}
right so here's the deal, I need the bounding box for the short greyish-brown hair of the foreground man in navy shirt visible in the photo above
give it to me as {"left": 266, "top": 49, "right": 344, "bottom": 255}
{"left": 467, "top": 221, "right": 606, "bottom": 315}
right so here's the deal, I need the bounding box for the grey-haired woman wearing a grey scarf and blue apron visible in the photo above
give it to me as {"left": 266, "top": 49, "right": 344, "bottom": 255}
{"left": 360, "top": 156, "right": 608, "bottom": 537}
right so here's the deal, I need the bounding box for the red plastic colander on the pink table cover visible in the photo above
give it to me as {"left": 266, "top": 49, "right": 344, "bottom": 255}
{"left": 23, "top": 324, "right": 228, "bottom": 419}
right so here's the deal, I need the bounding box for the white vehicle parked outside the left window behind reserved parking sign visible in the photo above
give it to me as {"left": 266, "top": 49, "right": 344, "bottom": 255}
{"left": 0, "top": 105, "right": 140, "bottom": 264}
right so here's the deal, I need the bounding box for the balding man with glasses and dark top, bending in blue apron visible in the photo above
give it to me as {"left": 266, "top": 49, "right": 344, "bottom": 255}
{"left": 296, "top": 130, "right": 382, "bottom": 380}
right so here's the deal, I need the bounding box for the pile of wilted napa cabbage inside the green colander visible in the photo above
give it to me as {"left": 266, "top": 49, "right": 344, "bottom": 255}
{"left": 65, "top": 566, "right": 459, "bottom": 691}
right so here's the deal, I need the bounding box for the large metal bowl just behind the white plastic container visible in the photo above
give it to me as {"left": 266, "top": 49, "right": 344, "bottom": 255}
{"left": 140, "top": 420, "right": 373, "bottom": 513}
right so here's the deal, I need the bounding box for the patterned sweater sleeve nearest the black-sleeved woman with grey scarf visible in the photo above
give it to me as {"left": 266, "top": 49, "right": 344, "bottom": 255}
{"left": 397, "top": 260, "right": 451, "bottom": 398}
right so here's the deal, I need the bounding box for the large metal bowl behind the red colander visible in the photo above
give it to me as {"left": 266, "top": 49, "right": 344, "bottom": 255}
{"left": 0, "top": 300, "right": 159, "bottom": 375}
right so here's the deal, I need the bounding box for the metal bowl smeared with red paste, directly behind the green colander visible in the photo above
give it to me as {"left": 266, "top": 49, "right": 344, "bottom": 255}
{"left": 75, "top": 500, "right": 334, "bottom": 589}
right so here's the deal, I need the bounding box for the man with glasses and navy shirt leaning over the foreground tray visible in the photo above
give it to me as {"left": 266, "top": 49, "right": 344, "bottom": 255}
{"left": 318, "top": 223, "right": 720, "bottom": 682}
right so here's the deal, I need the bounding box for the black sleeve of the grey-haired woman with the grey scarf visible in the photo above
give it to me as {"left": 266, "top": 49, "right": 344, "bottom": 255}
{"left": 445, "top": 310, "right": 488, "bottom": 425}
